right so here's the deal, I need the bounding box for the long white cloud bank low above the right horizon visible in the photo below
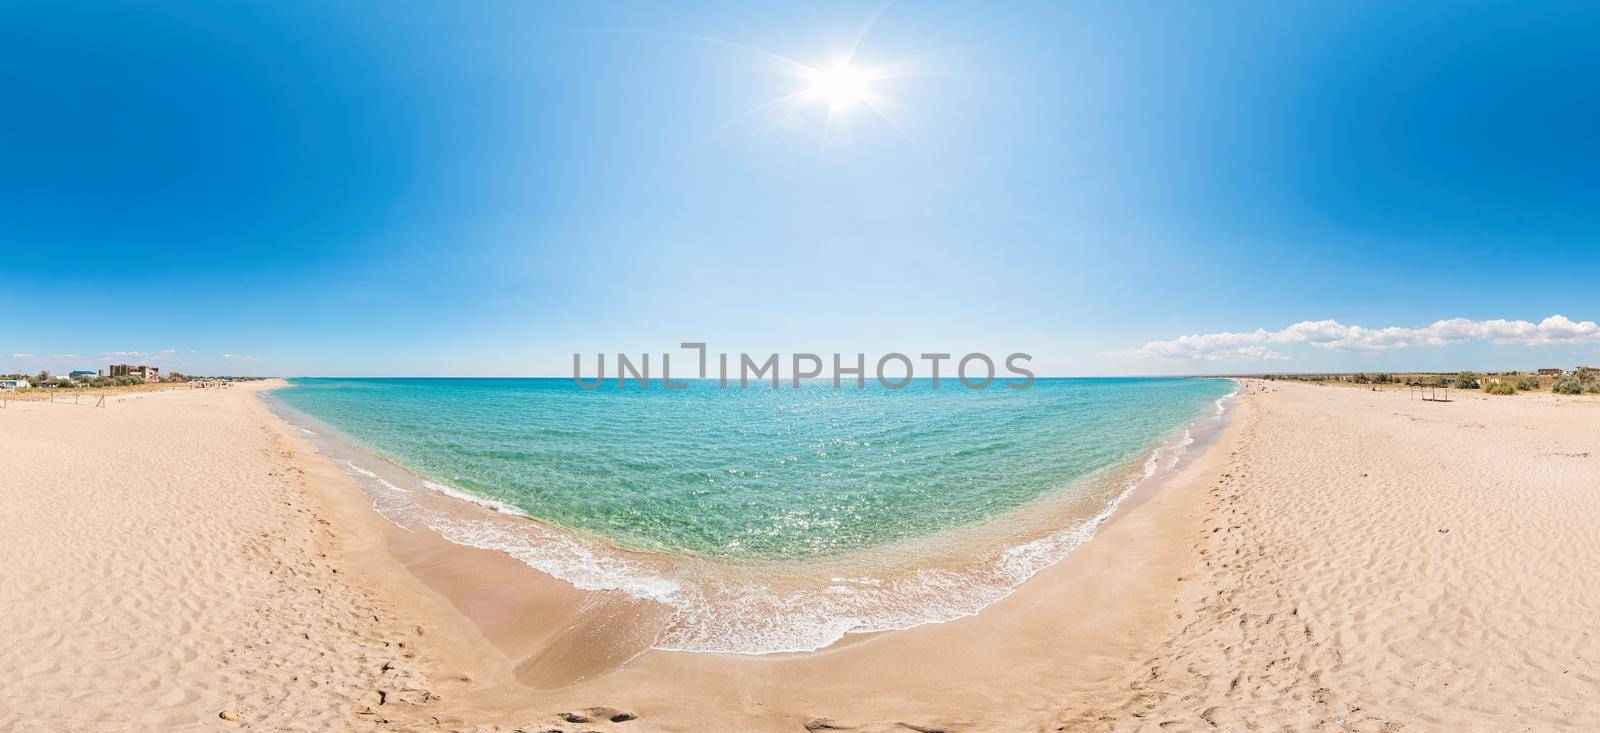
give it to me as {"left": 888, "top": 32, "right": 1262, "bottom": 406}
{"left": 1101, "top": 314, "right": 1600, "bottom": 362}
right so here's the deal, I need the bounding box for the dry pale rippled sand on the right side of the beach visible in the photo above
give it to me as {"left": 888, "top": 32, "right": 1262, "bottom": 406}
{"left": 1062, "top": 383, "right": 1600, "bottom": 731}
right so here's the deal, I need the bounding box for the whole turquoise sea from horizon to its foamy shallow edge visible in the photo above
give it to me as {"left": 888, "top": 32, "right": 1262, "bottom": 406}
{"left": 274, "top": 379, "right": 1234, "bottom": 653}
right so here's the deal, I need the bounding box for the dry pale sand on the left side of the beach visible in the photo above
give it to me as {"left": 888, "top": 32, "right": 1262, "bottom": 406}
{"left": 0, "top": 386, "right": 464, "bottom": 731}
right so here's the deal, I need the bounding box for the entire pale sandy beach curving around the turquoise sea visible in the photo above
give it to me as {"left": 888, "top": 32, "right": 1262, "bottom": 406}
{"left": 0, "top": 381, "right": 1600, "bottom": 731}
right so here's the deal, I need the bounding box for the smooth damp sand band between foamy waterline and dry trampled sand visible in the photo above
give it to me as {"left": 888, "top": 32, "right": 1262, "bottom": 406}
{"left": 278, "top": 380, "right": 1229, "bottom": 730}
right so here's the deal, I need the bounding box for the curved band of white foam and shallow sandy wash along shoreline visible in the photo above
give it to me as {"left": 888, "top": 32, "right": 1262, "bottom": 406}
{"left": 272, "top": 377, "right": 1237, "bottom": 655}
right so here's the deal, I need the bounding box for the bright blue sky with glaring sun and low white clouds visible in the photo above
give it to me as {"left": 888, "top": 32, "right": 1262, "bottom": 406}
{"left": 0, "top": 0, "right": 1600, "bottom": 376}
